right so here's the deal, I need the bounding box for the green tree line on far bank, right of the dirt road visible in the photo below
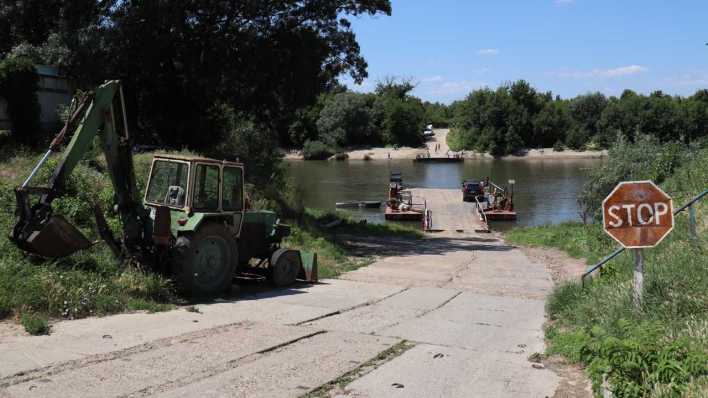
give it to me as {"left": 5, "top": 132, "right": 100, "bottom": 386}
{"left": 448, "top": 80, "right": 708, "bottom": 155}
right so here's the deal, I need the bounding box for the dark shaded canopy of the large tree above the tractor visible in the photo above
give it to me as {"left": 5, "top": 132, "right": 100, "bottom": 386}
{"left": 0, "top": 0, "right": 391, "bottom": 149}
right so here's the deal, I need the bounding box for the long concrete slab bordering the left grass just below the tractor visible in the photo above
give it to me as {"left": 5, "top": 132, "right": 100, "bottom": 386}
{"left": 0, "top": 301, "right": 330, "bottom": 379}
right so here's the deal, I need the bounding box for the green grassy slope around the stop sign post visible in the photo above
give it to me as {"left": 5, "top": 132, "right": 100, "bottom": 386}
{"left": 506, "top": 150, "right": 708, "bottom": 397}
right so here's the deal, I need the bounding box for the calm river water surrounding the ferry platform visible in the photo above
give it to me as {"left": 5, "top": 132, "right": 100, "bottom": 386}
{"left": 286, "top": 159, "right": 602, "bottom": 230}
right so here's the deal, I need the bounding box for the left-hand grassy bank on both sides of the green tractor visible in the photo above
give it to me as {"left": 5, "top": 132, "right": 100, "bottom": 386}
{"left": 0, "top": 149, "right": 417, "bottom": 333}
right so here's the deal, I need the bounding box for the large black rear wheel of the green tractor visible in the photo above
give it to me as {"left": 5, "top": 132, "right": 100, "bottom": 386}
{"left": 175, "top": 223, "right": 238, "bottom": 296}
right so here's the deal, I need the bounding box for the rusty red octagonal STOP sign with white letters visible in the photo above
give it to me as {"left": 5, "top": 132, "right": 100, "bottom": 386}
{"left": 602, "top": 181, "right": 674, "bottom": 249}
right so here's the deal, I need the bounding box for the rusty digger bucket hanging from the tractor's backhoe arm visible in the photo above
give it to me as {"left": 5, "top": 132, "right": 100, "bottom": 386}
{"left": 23, "top": 215, "right": 91, "bottom": 258}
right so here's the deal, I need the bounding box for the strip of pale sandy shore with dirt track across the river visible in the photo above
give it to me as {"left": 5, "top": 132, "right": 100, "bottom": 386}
{"left": 285, "top": 129, "right": 607, "bottom": 160}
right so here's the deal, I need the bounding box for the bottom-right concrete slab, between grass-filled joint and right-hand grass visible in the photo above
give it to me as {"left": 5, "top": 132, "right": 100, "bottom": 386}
{"left": 343, "top": 344, "right": 558, "bottom": 398}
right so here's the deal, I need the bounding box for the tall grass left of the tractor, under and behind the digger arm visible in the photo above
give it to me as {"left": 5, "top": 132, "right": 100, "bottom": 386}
{"left": 0, "top": 151, "right": 185, "bottom": 333}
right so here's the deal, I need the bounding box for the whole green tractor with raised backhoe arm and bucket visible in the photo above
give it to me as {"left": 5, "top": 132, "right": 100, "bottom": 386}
{"left": 11, "top": 81, "right": 317, "bottom": 296}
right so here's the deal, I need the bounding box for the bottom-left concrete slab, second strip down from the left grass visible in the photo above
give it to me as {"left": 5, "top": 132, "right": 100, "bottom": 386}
{"left": 6, "top": 322, "right": 314, "bottom": 397}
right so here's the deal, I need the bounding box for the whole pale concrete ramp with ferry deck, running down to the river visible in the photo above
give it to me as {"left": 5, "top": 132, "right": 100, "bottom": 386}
{"left": 0, "top": 190, "right": 560, "bottom": 398}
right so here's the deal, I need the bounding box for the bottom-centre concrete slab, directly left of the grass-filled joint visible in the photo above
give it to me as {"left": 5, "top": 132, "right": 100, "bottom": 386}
{"left": 158, "top": 332, "right": 397, "bottom": 398}
